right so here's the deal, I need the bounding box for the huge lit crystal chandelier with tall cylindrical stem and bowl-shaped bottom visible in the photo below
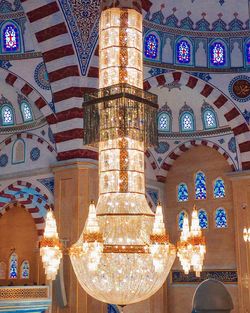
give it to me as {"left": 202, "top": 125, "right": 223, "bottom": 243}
{"left": 67, "top": 0, "right": 176, "bottom": 305}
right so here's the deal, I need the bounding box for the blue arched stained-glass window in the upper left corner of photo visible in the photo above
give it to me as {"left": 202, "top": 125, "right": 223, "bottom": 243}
{"left": 3, "top": 23, "right": 20, "bottom": 52}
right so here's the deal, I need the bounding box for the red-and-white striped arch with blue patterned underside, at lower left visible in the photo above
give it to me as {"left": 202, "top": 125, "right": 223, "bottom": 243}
{"left": 0, "top": 181, "right": 53, "bottom": 239}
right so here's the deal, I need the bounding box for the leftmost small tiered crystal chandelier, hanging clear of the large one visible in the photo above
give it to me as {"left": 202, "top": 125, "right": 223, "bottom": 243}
{"left": 40, "top": 210, "right": 62, "bottom": 281}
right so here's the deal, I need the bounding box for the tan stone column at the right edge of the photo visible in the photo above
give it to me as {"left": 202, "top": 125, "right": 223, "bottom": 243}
{"left": 229, "top": 171, "right": 250, "bottom": 313}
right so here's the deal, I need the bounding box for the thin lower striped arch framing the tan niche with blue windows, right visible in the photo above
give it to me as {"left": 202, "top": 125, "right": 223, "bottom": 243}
{"left": 146, "top": 139, "right": 237, "bottom": 183}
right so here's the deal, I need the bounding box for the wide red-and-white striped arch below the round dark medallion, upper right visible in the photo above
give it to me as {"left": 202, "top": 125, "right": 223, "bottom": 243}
{"left": 144, "top": 72, "right": 250, "bottom": 170}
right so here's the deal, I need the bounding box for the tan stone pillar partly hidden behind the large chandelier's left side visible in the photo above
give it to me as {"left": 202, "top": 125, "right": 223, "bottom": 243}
{"left": 52, "top": 161, "right": 105, "bottom": 313}
